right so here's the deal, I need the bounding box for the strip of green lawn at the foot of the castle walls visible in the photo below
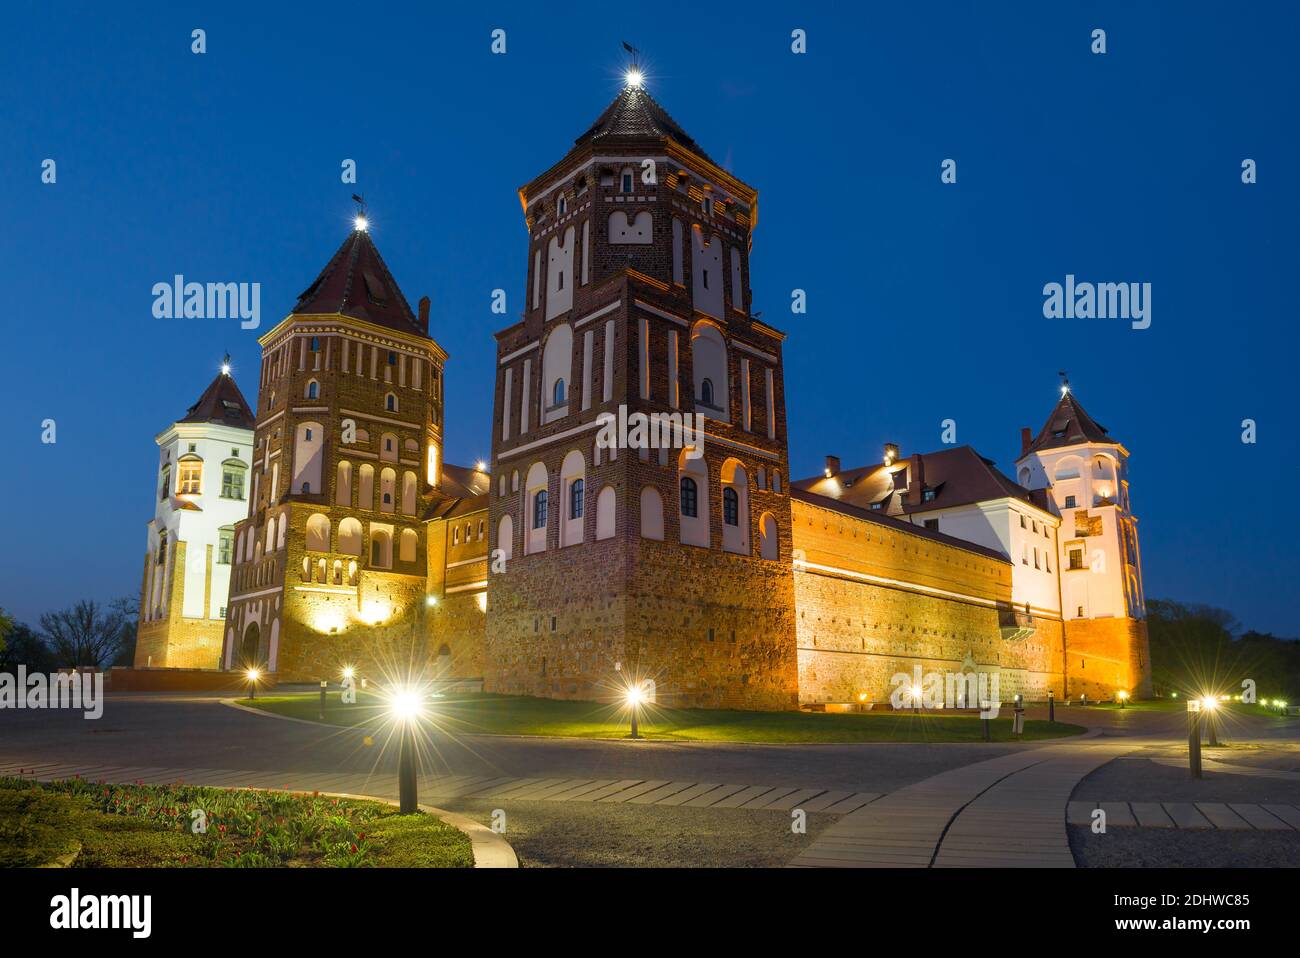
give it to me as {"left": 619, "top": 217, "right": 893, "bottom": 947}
{"left": 238, "top": 692, "right": 1084, "bottom": 744}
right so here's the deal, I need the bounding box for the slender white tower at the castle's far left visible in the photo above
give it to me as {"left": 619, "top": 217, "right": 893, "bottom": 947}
{"left": 135, "top": 357, "right": 254, "bottom": 668}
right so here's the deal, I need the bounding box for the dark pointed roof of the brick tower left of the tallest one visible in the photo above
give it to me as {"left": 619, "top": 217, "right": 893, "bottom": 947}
{"left": 290, "top": 230, "right": 429, "bottom": 335}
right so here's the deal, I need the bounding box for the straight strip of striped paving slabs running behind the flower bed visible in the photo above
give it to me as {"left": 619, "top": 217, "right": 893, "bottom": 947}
{"left": 0, "top": 762, "right": 880, "bottom": 815}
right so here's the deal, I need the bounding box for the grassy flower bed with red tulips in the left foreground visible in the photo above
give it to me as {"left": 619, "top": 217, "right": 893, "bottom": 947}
{"left": 0, "top": 777, "right": 473, "bottom": 868}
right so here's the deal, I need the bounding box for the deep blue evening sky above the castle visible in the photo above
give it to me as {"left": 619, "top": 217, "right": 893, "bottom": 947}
{"left": 0, "top": 0, "right": 1300, "bottom": 636}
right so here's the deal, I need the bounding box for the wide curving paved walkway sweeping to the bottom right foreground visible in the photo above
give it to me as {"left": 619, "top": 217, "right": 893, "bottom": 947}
{"left": 792, "top": 742, "right": 1136, "bottom": 868}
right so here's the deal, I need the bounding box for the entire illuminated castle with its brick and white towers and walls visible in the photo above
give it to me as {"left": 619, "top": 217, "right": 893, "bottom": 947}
{"left": 135, "top": 76, "right": 1151, "bottom": 710}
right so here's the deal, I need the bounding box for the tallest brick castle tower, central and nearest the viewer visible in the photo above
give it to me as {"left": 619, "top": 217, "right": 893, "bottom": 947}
{"left": 484, "top": 74, "right": 798, "bottom": 708}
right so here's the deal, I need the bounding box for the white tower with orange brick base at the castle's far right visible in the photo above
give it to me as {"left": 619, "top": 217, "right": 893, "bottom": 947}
{"left": 1017, "top": 381, "right": 1151, "bottom": 698}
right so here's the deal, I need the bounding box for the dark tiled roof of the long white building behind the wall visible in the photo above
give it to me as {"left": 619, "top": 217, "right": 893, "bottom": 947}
{"left": 793, "top": 446, "right": 1050, "bottom": 515}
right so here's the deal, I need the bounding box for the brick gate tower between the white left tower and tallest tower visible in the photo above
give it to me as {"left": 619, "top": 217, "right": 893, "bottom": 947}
{"left": 222, "top": 217, "right": 447, "bottom": 681}
